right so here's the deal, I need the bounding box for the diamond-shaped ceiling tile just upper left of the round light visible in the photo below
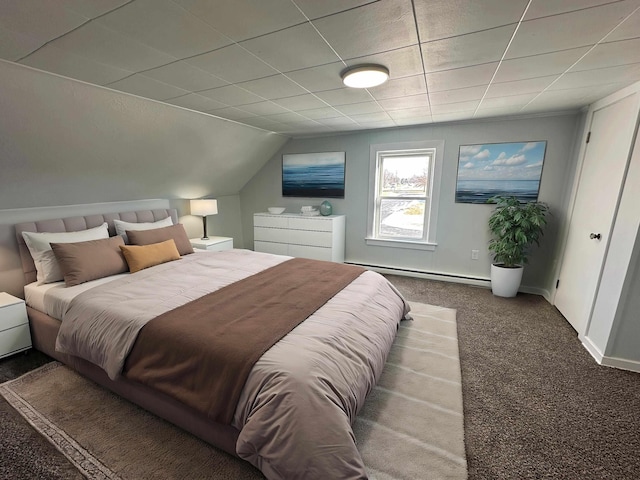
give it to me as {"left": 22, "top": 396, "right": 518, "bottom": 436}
{"left": 240, "top": 23, "right": 339, "bottom": 72}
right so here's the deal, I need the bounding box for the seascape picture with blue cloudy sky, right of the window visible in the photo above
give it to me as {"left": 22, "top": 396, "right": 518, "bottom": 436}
{"left": 456, "top": 141, "right": 547, "bottom": 203}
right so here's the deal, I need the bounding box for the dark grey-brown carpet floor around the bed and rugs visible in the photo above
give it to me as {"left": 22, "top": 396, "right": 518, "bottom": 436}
{"left": 0, "top": 275, "right": 640, "bottom": 480}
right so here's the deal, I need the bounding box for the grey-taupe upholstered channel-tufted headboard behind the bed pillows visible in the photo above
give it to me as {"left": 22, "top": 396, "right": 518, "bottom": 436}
{"left": 15, "top": 208, "right": 178, "bottom": 285}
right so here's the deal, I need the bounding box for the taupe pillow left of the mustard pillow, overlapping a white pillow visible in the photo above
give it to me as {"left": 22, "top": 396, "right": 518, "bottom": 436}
{"left": 51, "top": 237, "right": 129, "bottom": 287}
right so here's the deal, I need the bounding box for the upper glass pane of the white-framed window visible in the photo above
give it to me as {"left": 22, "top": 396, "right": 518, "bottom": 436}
{"left": 380, "top": 155, "right": 429, "bottom": 196}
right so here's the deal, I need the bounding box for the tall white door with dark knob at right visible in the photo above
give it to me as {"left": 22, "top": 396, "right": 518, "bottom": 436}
{"left": 554, "top": 94, "right": 639, "bottom": 334}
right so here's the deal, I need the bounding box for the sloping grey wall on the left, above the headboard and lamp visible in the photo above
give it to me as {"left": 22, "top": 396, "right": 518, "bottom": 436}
{"left": 0, "top": 61, "right": 288, "bottom": 243}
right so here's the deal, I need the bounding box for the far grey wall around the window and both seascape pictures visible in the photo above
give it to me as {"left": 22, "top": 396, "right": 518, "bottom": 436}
{"left": 240, "top": 115, "right": 579, "bottom": 295}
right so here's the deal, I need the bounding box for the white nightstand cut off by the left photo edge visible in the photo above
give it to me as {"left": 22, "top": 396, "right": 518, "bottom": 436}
{"left": 0, "top": 292, "right": 31, "bottom": 358}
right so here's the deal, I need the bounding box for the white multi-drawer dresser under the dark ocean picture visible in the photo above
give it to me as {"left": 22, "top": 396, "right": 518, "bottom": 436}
{"left": 253, "top": 213, "right": 345, "bottom": 262}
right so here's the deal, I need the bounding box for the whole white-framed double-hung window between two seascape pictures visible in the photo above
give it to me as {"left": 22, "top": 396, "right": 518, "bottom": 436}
{"left": 367, "top": 141, "right": 444, "bottom": 250}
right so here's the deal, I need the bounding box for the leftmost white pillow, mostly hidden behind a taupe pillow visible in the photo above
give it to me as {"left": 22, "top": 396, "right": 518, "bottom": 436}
{"left": 22, "top": 222, "right": 109, "bottom": 283}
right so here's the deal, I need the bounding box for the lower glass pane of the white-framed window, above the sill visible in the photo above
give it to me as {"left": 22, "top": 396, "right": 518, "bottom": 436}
{"left": 379, "top": 198, "right": 425, "bottom": 239}
